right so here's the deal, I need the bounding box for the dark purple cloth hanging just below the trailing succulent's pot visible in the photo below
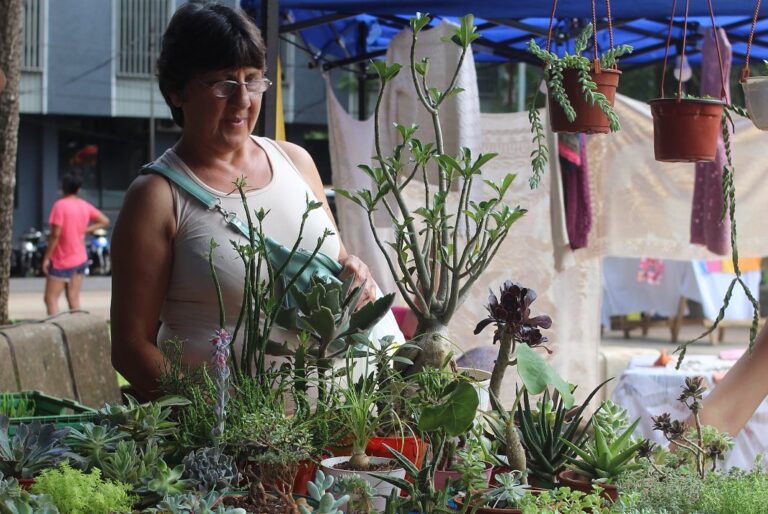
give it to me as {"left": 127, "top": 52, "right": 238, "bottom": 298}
{"left": 558, "top": 134, "right": 592, "bottom": 250}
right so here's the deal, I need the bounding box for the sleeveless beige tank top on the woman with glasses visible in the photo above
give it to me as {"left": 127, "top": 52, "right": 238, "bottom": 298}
{"left": 157, "top": 136, "right": 341, "bottom": 366}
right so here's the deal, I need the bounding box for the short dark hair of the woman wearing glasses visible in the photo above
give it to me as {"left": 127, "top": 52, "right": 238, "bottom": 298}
{"left": 157, "top": 2, "right": 266, "bottom": 127}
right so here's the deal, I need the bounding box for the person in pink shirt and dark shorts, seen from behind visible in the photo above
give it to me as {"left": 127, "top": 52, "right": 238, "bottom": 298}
{"left": 43, "top": 174, "right": 109, "bottom": 316}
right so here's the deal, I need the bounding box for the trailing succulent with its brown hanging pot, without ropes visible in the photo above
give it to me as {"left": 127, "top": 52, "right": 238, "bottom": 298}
{"left": 528, "top": 23, "right": 632, "bottom": 134}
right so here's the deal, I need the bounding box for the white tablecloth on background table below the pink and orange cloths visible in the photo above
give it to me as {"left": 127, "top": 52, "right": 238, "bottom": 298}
{"left": 601, "top": 257, "right": 760, "bottom": 326}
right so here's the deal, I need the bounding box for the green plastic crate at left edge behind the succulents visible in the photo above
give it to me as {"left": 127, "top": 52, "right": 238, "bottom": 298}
{"left": 3, "top": 391, "right": 96, "bottom": 435}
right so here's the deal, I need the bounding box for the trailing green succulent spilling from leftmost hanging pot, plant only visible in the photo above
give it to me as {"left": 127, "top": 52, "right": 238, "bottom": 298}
{"left": 528, "top": 23, "right": 632, "bottom": 188}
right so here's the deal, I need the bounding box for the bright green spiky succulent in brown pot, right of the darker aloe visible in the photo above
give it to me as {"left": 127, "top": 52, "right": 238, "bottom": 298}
{"left": 558, "top": 418, "right": 643, "bottom": 501}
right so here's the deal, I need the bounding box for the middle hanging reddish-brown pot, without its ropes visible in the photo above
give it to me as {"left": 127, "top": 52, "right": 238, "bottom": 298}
{"left": 649, "top": 98, "right": 724, "bottom": 162}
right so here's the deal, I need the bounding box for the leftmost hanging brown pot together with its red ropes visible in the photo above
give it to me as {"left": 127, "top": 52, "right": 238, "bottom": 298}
{"left": 546, "top": 0, "right": 621, "bottom": 134}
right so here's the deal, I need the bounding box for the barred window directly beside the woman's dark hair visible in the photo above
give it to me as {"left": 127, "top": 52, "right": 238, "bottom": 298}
{"left": 117, "top": 0, "right": 173, "bottom": 77}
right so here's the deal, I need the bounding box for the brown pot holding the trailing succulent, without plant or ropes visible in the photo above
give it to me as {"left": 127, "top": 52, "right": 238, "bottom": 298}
{"left": 548, "top": 68, "right": 621, "bottom": 134}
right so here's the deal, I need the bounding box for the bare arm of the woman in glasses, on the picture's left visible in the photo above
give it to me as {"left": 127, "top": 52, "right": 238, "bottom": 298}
{"left": 111, "top": 175, "right": 176, "bottom": 400}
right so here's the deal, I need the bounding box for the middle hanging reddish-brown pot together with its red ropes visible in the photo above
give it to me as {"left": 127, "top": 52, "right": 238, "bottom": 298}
{"left": 649, "top": 0, "right": 726, "bottom": 162}
